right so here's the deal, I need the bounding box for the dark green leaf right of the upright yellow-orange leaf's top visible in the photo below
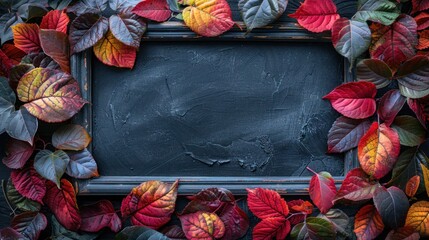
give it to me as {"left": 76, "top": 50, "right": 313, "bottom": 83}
{"left": 392, "top": 115, "right": 426, "bottom": 147}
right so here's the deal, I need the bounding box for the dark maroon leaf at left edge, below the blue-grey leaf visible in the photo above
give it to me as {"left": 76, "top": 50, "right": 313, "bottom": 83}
{"left": 3, "top": 138, "right": 34, "bottom": 169}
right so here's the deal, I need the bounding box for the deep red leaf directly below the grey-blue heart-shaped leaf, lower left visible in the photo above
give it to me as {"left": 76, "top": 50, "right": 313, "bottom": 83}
{"left": 43, "top": 179, "right": 82, "bottom": 231}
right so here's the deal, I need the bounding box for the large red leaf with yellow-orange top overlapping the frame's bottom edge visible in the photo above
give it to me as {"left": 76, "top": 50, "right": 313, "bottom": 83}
{"left": 121, "top": 181, "right": 178, "bottom": 229}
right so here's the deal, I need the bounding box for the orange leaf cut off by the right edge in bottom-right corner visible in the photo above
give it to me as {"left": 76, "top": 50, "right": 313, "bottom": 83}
{"left": 405, "top": 201, "right": 429, "bottom": 237}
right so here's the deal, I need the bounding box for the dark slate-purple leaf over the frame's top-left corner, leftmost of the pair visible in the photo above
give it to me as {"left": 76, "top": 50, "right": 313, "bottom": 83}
{"left": 69, "top": 13, "right": 109, "bottom": 53}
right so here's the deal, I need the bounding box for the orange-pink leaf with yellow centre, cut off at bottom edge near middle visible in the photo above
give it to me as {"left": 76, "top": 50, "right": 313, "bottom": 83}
{"left": 179, "top": 212, "right": 225, "bottom": 239}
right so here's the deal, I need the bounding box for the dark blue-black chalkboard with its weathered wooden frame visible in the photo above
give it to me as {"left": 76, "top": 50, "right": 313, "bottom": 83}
{"left": 72, "top": 1, "right": 357, "bottom": 195}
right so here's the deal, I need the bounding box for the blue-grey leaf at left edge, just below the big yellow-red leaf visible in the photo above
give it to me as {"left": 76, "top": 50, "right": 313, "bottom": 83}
{"left": 6, "top": 107, "right": 39, "bottom": 145}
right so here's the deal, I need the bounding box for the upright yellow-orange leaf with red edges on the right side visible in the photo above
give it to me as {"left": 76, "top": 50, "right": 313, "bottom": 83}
{"left": 358, "top": 122, "right": 400, "bottom": 179}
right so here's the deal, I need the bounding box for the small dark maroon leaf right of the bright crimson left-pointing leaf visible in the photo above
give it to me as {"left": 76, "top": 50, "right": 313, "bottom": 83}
{"left": 377, "top": 89, "right": 407, "bottom": 126}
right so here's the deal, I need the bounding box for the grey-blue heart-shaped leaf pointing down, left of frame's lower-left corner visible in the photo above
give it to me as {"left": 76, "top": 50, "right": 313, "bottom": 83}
{"left": 34, "top": 150, "right": 70, "bottom": 188}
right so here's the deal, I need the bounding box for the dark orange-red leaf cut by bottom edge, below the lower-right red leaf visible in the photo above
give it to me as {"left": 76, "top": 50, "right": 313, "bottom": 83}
{"left": 354, "top": 205, "right": 384, "bottom": 240}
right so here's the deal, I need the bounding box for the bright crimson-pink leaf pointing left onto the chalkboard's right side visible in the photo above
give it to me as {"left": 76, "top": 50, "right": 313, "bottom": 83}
{"left": 323, "top": 82, "right": 377, "bottom": 119}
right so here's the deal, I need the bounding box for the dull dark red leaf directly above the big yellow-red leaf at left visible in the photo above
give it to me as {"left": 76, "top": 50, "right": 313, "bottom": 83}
{"left": 39, "top": 30, "right": 70, "bottom": 73}
